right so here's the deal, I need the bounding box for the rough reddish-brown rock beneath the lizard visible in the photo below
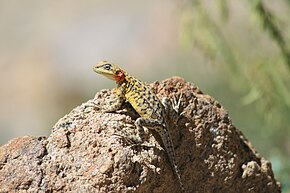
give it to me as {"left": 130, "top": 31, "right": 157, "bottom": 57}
{"left": 0, "top": 77, "right": 281, "bottom": 193}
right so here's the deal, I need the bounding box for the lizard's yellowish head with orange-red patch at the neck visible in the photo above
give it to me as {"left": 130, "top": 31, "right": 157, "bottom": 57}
{"left": 93, "top": 61, "right": 125, "bottom": 83}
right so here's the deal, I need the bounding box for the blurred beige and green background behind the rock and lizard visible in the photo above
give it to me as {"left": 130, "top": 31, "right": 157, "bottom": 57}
{"left": 0, "top": 0, "right": 290, "bottom": 192}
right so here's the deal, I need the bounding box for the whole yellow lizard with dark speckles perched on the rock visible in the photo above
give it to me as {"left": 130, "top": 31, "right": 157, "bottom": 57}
{"left": 93, "top": 61, "right": 185, "bottom": 192}
